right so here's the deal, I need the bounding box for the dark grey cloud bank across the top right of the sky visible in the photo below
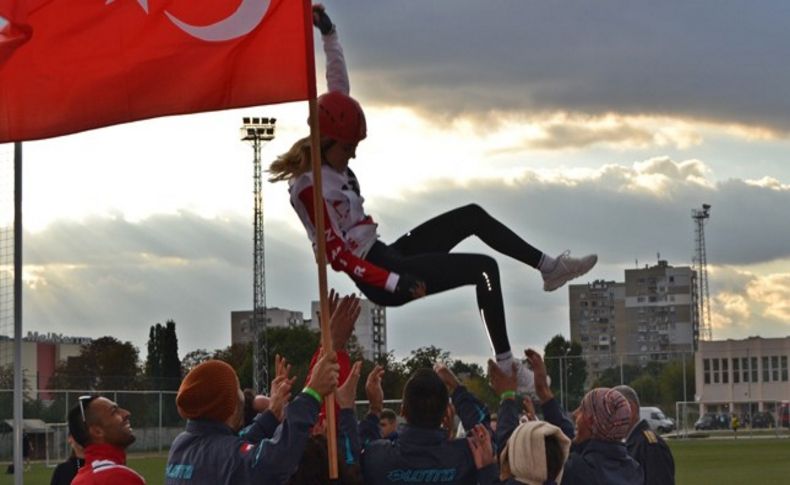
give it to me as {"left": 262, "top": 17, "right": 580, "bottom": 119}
{"left": 328, "top": 0, "right": 790, "bottom": 134}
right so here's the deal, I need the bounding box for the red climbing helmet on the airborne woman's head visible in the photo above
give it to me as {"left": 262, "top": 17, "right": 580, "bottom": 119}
{"left": 318, "top": 91, "right": 368, "bottom": 143}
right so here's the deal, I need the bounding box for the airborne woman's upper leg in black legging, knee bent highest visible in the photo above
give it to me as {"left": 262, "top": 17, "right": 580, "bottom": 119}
{"left": 392, "top": 204, "right": 543, "bottom": 268}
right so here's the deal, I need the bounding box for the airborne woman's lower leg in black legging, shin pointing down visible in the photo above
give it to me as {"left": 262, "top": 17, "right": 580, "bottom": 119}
{"left": 357, "top": 248, "right": 510, "bottom": 354}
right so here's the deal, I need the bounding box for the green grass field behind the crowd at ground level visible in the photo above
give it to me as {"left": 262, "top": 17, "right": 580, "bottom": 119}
{"left": 0, "top": 438, "right": 790, "bottom": 485}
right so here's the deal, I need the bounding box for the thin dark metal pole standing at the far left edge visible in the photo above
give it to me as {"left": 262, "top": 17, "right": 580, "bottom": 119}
{"left": 14, "top": 142, "right": 24, "bottom": 485}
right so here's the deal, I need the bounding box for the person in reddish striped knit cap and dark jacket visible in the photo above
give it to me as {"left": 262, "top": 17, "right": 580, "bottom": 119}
{"left": 562, "top": 387, "right": 644, "bottom": 485}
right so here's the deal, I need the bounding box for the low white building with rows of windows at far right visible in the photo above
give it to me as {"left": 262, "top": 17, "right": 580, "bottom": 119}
{"left": 695, "top": 337, "right": 790, "bottom": 413}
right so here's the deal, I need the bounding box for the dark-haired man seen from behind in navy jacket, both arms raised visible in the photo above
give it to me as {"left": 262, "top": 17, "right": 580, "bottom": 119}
{"left": 360, "top": 366, "right": 496, "bottom": 485}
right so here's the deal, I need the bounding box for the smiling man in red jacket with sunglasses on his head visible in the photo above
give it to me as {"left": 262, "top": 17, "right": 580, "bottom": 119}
{"left": 68, "top": 395, "right": 145, "bottom": 485}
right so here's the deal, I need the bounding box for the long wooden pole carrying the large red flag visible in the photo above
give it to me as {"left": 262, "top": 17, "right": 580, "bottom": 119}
{"left": 310, "top": 98, "right": 338, "bottom": 480}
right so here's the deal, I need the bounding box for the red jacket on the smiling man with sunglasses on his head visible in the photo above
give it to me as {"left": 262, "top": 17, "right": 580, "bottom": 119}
{"left": 71, "top": 444, "right": 145, "bottom": 485}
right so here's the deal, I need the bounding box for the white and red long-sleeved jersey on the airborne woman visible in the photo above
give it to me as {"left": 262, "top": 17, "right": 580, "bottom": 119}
{"left": 288, "top": 165, "right": 399, "bottom": 292}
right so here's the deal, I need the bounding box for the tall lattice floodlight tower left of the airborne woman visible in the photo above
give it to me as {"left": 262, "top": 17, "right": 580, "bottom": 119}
{"left": 241, "top": 117, "right": 277, "bottom": 393}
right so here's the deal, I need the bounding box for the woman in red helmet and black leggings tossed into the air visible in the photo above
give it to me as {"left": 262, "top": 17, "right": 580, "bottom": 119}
{"left": 269, "top": 6, "right": 598, "bottom": 393}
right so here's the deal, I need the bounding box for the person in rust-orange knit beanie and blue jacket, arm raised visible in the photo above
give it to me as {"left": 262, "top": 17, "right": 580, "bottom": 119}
{"left": 165, "top": 354, "right": 338, "bottom": 485}
